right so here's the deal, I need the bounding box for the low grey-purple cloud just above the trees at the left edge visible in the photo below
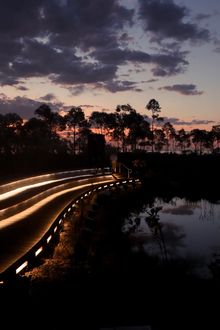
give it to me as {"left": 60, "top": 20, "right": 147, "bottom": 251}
{"left": 0, "top": 93, "right": 63, "bottom": 119}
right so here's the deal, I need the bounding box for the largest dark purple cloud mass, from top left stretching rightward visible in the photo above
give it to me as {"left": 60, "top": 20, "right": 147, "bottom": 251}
{"left": 0, "top": 0, "right": 192, "bottom": 92}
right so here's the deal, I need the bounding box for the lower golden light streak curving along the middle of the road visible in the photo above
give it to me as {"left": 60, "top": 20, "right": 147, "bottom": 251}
{"left": 0, "top": 175, "right": 112, "bottom": 229}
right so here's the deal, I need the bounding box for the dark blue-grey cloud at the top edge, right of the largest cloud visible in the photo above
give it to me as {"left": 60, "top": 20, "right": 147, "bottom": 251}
{"left": 139, "top": 0, "right": 210, "bottom": 43}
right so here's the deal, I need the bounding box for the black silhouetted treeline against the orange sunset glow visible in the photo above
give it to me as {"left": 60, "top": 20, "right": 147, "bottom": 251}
{"left": 0, "top": 100, "right": 220, "bottom": 179}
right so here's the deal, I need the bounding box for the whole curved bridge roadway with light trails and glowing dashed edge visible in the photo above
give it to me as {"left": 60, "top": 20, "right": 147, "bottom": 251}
{"left": 0, "top": 168, "right": 139, "bottom": 284}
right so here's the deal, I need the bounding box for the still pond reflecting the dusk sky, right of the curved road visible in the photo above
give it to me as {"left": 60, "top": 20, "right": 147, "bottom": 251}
{"left": 122, "top": 197, "right": 220, "bottom": 279}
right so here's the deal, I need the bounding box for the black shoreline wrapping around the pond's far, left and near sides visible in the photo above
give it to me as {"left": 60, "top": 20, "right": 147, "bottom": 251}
{"left": 0, "top": 154, "right": 220, "bottom": 330}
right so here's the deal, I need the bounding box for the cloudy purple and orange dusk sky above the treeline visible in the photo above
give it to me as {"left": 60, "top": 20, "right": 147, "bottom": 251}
{"left": 0, "top": 0, "right": 220, "bottom": 129}
